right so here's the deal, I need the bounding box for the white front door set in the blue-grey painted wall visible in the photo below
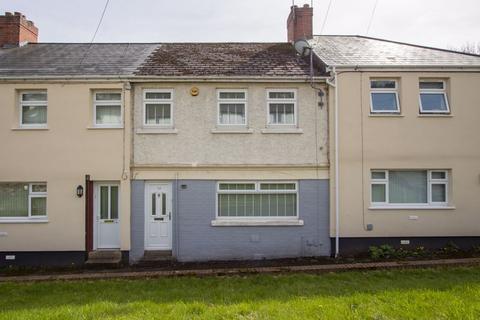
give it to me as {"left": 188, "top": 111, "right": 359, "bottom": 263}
{"left": 145, "top": 183, "right": 172, "bottom": 250}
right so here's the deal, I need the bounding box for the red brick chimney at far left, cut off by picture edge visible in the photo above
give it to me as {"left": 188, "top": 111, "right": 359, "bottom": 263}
{"left": 0, "top": 12, "right": 38, "bottom": 48}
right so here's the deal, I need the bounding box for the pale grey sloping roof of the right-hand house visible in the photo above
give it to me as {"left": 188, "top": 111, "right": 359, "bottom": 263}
{"left": 310, "top": 35, "right": 480, "bottom": 67}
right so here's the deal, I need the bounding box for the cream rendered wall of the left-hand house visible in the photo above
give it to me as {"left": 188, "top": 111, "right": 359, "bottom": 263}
{"left": 0, "top": 80, "right": 131, "bottom": 264}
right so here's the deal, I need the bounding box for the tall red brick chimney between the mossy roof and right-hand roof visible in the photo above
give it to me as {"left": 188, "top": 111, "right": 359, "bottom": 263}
{"left": 287, "top": 4, "right": 313, "bottom": 42}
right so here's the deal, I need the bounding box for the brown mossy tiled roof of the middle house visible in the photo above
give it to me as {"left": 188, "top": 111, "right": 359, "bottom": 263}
{"left": 135, "top": 43, "right": 316, "bottom": 77}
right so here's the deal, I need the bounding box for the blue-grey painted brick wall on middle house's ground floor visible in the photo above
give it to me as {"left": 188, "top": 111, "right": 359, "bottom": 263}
{"left": 130, "top": 180, "right": 330, "bottom": 261}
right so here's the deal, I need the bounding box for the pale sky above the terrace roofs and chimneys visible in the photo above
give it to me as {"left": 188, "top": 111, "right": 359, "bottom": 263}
{"left": 0, "top": 0, "right": 480, "bottom": 47}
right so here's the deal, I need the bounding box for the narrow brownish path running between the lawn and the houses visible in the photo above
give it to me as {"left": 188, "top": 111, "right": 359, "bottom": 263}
{"left": 0, "top": 258, "right": 480, "bottom": 282}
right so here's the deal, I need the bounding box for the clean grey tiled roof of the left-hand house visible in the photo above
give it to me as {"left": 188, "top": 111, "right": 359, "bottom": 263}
{"left": 0, "top": 43, "right": 158, "bottom": 77}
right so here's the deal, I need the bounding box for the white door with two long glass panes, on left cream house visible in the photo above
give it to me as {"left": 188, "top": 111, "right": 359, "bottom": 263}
{"left": 94, "top": 183, "right": 120, "bottom": 249}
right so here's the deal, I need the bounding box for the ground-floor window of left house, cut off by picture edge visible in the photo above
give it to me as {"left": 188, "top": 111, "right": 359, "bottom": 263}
{"left": 0, "top": 182, "right": 47, "bottom": 223}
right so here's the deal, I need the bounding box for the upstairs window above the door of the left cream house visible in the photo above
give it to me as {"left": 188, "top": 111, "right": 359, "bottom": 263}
{"left": 93, "top": 91, "right": 123, "bottom": 128}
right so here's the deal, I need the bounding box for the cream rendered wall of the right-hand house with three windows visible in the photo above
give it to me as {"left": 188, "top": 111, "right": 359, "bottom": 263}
{"left": 329, "top": 68, "right": 480, "bottom": 254}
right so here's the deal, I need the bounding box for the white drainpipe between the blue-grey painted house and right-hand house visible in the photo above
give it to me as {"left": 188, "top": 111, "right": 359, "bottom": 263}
{"left": 327, "top": 67, "right": 340, "bottom": 258}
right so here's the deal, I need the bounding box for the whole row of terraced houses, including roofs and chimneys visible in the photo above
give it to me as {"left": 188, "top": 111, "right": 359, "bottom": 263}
{"left": 0, "top": 5, "right": 480, "bottom": 265}
